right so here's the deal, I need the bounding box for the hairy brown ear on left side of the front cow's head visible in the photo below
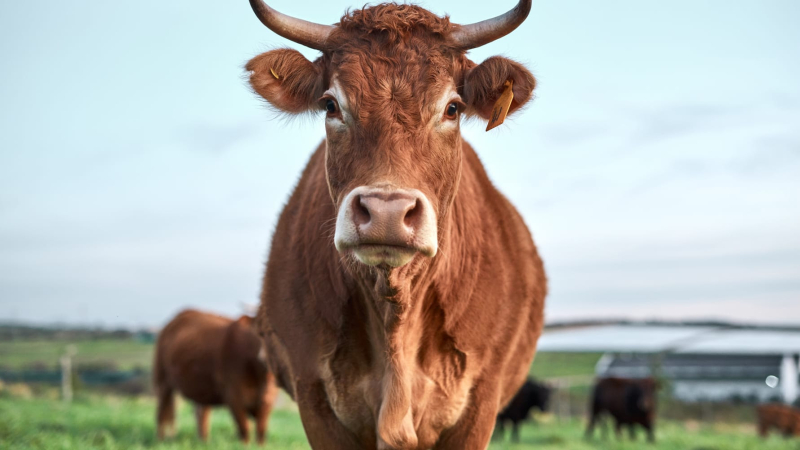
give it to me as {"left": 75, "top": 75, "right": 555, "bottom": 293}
{"left": 245, "top": 48, "right": 323, "bottom": 114}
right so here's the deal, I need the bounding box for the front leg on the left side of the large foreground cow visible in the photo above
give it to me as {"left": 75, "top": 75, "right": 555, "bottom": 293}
{"left": 295, "top": 380, "right": 365, "bottom": 450}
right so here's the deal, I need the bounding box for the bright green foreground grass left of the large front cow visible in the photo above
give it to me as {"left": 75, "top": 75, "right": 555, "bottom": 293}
{"left": 0, "top": 396, "right": 308, "bottom": 450}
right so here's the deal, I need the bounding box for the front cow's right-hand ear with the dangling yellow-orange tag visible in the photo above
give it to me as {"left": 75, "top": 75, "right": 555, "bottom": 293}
{"left": 464, "top": 56, "right": 536, "bottom": 120}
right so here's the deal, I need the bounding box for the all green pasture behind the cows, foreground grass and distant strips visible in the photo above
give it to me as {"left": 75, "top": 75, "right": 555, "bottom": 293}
{"left": 0, "top": 338, "right": 800, "bottom": 450}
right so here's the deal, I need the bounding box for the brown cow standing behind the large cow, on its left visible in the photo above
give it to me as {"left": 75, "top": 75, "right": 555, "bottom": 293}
{"left": 153, "top": 310, "right": 277, "bottom": 443}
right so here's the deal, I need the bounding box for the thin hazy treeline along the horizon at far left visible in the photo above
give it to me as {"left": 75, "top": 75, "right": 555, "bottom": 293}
{"left": 0, "top": 323, "right": 155, "bottom": 342}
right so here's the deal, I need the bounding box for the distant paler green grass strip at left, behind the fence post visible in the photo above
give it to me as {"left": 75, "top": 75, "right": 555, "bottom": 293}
{"left": 0, "top": 339, "right": 153, "bottom": 370}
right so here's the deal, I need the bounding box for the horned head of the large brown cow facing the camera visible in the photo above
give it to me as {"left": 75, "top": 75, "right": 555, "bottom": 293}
{"left": 246, "top": 0, "right": 535, "bottom": 267}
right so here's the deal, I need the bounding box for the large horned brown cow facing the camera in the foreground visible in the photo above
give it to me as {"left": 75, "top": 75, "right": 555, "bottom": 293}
{"left": 247, "top": 0, "right": 546, "bottom": 450}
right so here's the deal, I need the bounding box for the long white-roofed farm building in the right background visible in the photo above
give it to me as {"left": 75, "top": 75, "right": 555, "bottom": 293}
{"left": 539, "top": 325, "right": 800, "bottom": 403}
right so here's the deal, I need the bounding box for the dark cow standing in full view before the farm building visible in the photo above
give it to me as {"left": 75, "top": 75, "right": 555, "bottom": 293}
{"left": 586, "top": 377, "right": 657, "bottom": 442}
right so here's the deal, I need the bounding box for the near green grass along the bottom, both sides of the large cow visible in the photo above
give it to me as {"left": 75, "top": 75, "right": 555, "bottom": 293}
{"left": 0, "top": 396, "right": 800, "bottom": 450}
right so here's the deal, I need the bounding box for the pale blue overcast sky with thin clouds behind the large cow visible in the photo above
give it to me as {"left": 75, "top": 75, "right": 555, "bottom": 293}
{"left": 0, "top": 0, "right": 800, "bottom": 326}
